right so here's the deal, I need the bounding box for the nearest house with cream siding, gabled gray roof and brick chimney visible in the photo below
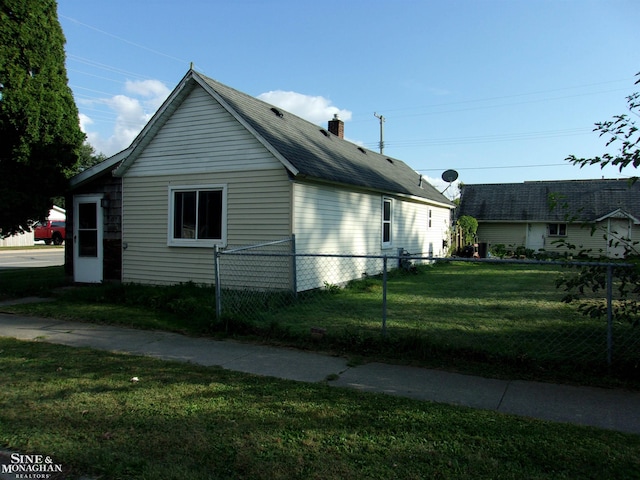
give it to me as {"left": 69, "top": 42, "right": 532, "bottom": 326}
{"left": 67, "top": 70, "right": 453, "bottom": 290}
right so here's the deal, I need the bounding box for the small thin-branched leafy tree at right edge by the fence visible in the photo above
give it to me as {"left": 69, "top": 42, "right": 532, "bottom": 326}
{"left": 556, "top": 72, "right": 640, "bottom": 325}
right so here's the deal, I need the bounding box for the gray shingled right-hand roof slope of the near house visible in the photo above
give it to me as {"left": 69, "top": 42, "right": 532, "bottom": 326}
{"left": 193, "top": 72, "right": 452, "bottom": 205}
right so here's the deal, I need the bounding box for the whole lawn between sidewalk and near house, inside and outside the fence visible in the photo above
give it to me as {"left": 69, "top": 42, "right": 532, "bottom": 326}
{"left": 5, "top": 263, "right": 640, "bottom": 388}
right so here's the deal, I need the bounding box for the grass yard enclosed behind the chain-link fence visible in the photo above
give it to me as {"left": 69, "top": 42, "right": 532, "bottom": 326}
{"left": 223, "top": 263, "right": 640, "bottom": 383}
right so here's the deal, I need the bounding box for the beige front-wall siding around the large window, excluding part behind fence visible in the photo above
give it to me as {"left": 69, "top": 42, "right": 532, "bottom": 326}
{"left": 123, "top": 169, "right": 291, "bottom": 284}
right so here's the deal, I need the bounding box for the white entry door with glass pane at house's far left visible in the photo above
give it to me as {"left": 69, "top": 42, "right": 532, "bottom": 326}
{"left": 73, "top": 195, "right": 103, "bottom": 283}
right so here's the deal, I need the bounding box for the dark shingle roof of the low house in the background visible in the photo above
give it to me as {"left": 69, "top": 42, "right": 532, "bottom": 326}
{"left": 458, "top": 180, "right": 640, "bottom": 222}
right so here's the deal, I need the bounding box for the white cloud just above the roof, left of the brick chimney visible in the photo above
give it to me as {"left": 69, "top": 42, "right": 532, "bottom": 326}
{"left": 258, "top": 90, "right": 351, "bottom": 124}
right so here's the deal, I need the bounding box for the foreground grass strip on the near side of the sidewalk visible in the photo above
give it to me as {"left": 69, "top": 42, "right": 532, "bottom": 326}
{"left": 0, "top": 339, "right": 640, "bottom": 480}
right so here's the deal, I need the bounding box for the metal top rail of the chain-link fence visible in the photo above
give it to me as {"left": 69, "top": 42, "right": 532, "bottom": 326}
{"left": 219, "top": 249, "right": 634, "bottom": 268}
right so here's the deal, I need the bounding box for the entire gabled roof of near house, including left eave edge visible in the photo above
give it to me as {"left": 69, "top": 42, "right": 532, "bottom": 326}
{"left": 116, "top": 70, "right": 453, "bottom": 207}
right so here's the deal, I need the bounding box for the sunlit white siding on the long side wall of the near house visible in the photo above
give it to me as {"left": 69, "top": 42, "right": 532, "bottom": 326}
{"left": 293, "top": 183, "right": 449, "bottom": 290}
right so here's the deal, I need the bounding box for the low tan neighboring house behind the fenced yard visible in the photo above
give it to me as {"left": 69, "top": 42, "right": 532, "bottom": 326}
{"left": 457, "top": 180, "right": 640, "bottom": 258}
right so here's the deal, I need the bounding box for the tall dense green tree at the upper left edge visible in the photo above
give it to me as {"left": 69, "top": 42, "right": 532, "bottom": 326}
{"left": 0, "top": 0, "right": 84, "bottom": 236}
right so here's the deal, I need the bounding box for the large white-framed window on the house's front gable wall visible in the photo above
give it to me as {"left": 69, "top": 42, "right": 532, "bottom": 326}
{"left": 167, "top": 185, "right": 227, "bottom": 247}
